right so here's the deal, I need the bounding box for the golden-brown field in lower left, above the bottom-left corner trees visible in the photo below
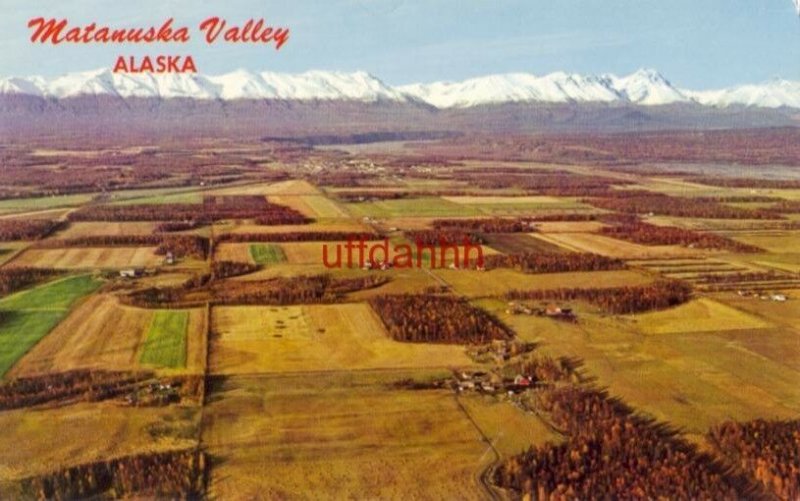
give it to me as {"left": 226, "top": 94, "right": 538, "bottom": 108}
{"left": 0, "top": 402, "right": 199, "bottom": 482}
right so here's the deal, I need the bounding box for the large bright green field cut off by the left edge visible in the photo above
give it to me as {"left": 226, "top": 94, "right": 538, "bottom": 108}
{"left": 0, "top": 275, "right": 100, "bottom": 377}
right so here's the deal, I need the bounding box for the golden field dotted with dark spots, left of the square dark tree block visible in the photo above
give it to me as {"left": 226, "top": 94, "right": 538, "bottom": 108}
{"left": 209, "top": 303, "right": 471, "bottom": 374}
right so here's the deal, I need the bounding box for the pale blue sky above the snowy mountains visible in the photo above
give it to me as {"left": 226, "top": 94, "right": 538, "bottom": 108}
{"left": 0, "top": 0, "right": 800, "bottom": 88}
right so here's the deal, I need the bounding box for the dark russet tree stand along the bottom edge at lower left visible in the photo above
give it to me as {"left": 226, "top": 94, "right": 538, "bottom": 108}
{"left": 22, "top": 448, "right": 207, "bottom": 499}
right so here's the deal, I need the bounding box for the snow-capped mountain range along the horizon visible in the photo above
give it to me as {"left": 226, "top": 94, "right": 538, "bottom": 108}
{"left": 0, "top": 69, "right": 800, "bottom": 108}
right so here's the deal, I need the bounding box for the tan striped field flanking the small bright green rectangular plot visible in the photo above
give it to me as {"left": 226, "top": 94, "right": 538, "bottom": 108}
{"left": 10, "top": 294, "right": 206, "bottom": 377}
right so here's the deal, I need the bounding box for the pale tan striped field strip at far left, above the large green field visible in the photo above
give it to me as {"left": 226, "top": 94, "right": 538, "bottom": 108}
{"left": 10, "top": 247, "right": 164, "bottom": 270}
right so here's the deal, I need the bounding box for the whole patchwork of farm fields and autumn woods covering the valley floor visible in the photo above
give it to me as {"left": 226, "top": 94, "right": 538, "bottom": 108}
{"left": 0, "top": 131, "right": 800, "bottom": 499}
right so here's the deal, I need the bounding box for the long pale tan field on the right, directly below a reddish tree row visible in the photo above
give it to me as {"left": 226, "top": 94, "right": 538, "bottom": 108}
{"left": 532, "top": 233, "right": 702, "bottom": 259}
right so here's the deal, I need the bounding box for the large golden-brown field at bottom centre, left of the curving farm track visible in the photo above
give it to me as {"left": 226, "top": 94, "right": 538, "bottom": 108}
{"left": 202, "top": 373, "right": 494, "bottom": 500}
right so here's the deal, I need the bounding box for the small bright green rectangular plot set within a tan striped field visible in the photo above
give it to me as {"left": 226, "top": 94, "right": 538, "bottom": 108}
{"left": 139, "top": 310, "right": 189, "bottom": 369}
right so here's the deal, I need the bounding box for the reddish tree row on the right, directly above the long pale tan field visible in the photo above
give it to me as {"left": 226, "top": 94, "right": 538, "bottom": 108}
{"left": 600, "top": 221, "right": 764, "bottom": 253}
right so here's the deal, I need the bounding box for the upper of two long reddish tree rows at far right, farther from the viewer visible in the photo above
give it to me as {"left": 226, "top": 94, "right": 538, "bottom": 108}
{"left": 583, "top": 191, "right": 781, "bottom": 219}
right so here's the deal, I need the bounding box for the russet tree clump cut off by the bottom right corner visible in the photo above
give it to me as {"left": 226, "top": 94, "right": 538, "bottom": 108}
{"left": 708, "top": 419, "right": 800, "bottom": 501}
